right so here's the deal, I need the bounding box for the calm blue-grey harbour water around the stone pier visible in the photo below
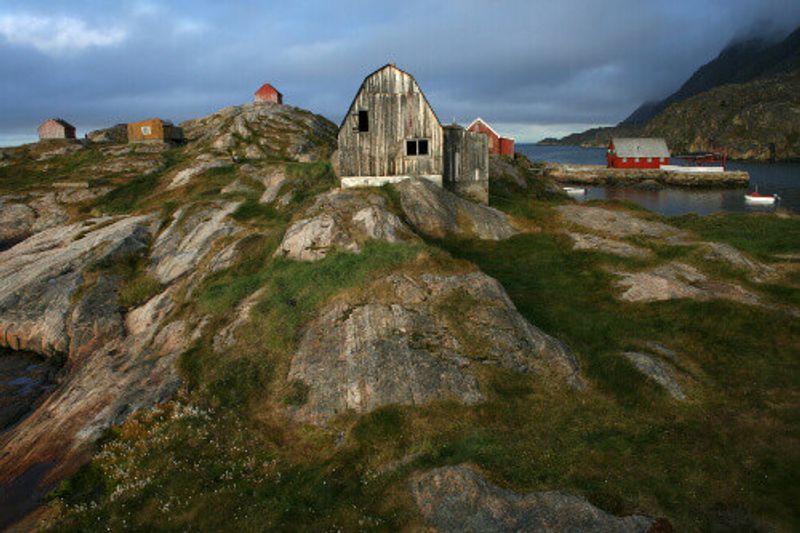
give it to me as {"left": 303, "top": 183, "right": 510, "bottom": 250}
{"left": 517, "top": 144, "right": 800, "bottom": 216}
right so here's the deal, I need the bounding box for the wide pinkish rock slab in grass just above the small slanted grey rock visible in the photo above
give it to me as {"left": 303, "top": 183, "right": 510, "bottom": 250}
{"left": 616, "top": 262, "right": 760, "bottom": 305}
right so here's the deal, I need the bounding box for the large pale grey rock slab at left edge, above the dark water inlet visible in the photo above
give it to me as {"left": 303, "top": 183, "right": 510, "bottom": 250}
{"left": 0, "top": 216, "right": 153, "bottom": 355}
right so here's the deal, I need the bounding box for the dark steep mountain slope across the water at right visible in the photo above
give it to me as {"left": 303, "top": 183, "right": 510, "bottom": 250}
{"left": 551, "top": 28, "right": 800, "bottom": 161}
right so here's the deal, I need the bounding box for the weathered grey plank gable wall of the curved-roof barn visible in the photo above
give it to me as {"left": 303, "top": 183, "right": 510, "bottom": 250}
{"left": 339, "top": 65, "right": 443, "bottom": 176}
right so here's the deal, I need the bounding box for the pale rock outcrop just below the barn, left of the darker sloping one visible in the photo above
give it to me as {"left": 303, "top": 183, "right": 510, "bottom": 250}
{"left": 275, "top": 189, "right": 417, "bottom": 261}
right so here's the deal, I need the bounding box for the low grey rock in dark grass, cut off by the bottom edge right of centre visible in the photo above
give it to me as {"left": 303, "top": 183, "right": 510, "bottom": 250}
{"left": 411, "top": 466, "right": 656, "bottom": 533}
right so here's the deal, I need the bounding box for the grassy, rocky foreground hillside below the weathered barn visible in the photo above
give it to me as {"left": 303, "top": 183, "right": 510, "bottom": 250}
{"left": 0, "top": 104, "right": 800, "bottom": 531}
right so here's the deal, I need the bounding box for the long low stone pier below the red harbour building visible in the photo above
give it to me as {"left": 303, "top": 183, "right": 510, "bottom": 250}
{"left": 544, "top": 163, "right": 750, "bottom": 188}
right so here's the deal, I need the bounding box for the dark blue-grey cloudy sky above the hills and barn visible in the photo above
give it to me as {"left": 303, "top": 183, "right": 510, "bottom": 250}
{"left": 0, "top": 0, "right": 800, "bottom": 146}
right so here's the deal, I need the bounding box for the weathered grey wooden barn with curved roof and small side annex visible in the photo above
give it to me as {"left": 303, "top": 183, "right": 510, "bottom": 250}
{"left": 338, "top": 64, "right": 489, "bottom": 202}
